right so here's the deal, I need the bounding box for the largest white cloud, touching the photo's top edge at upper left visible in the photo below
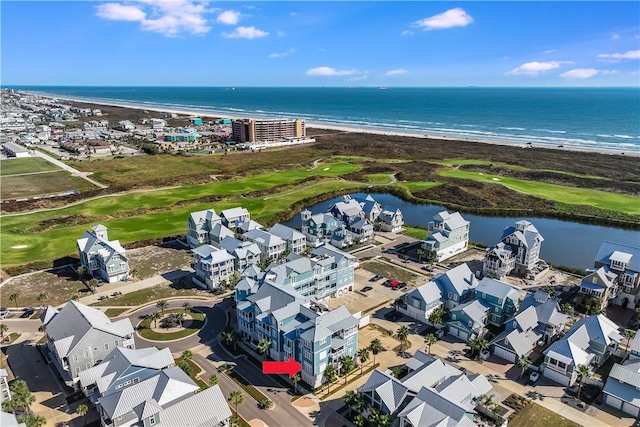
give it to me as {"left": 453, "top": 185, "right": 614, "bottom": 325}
{"left": 96, "top": 0, "right": 211, "bottom": 37}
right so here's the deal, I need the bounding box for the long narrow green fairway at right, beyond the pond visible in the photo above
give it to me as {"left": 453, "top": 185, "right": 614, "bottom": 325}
{"left": 438, "top": 170, "right": 640, "bottom": 215}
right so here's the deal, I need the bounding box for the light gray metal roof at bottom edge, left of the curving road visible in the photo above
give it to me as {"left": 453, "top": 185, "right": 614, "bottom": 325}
{"left": 160, "top": 385, "right": 231, "bottom": 427}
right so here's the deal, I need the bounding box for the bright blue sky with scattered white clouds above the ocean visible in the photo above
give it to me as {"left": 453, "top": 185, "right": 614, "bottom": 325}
{"left": 0, "top": 0, "right": 640, "bottom": 86}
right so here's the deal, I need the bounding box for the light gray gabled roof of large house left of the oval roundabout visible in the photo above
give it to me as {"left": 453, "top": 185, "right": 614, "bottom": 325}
{"left": 47, "top": 301, "right": 134, "bottom": 358}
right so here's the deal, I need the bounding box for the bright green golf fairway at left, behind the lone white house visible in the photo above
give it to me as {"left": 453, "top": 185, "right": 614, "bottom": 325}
{"left": 0, "top": 176, "right": 359, "bottom": 268}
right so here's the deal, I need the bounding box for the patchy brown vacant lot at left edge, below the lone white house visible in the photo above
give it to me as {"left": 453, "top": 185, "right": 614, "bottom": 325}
{"left": 2, "top": 267, "right": 89, "bottom": 307}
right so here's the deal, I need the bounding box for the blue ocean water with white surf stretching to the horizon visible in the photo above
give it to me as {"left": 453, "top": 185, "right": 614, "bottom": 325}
{"left": 16, "top": 86, "right": 640, "bottom": 153}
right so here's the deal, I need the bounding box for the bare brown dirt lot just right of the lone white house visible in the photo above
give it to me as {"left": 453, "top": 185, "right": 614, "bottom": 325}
{"left": 127, "top": 241, "right": 192, "bottom": 280}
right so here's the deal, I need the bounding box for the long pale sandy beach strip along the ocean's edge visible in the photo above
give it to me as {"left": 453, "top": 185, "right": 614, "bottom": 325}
{"left": 21, "top": 91, "right": 640, "bottom": 157}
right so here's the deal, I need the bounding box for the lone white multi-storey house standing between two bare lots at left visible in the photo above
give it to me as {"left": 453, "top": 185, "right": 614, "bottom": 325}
{"left": 76, "top": 224, "right": 129, "bottom": 283}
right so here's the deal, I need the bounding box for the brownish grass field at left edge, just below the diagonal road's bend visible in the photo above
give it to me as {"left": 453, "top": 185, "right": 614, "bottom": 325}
{"left": 0, "top": 170, "right": 96, "bottom": 199}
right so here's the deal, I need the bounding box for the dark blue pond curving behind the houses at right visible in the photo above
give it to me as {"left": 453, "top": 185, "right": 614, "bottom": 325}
{"left": 286, "top": 193, "right": 640, "bottom": 269}
